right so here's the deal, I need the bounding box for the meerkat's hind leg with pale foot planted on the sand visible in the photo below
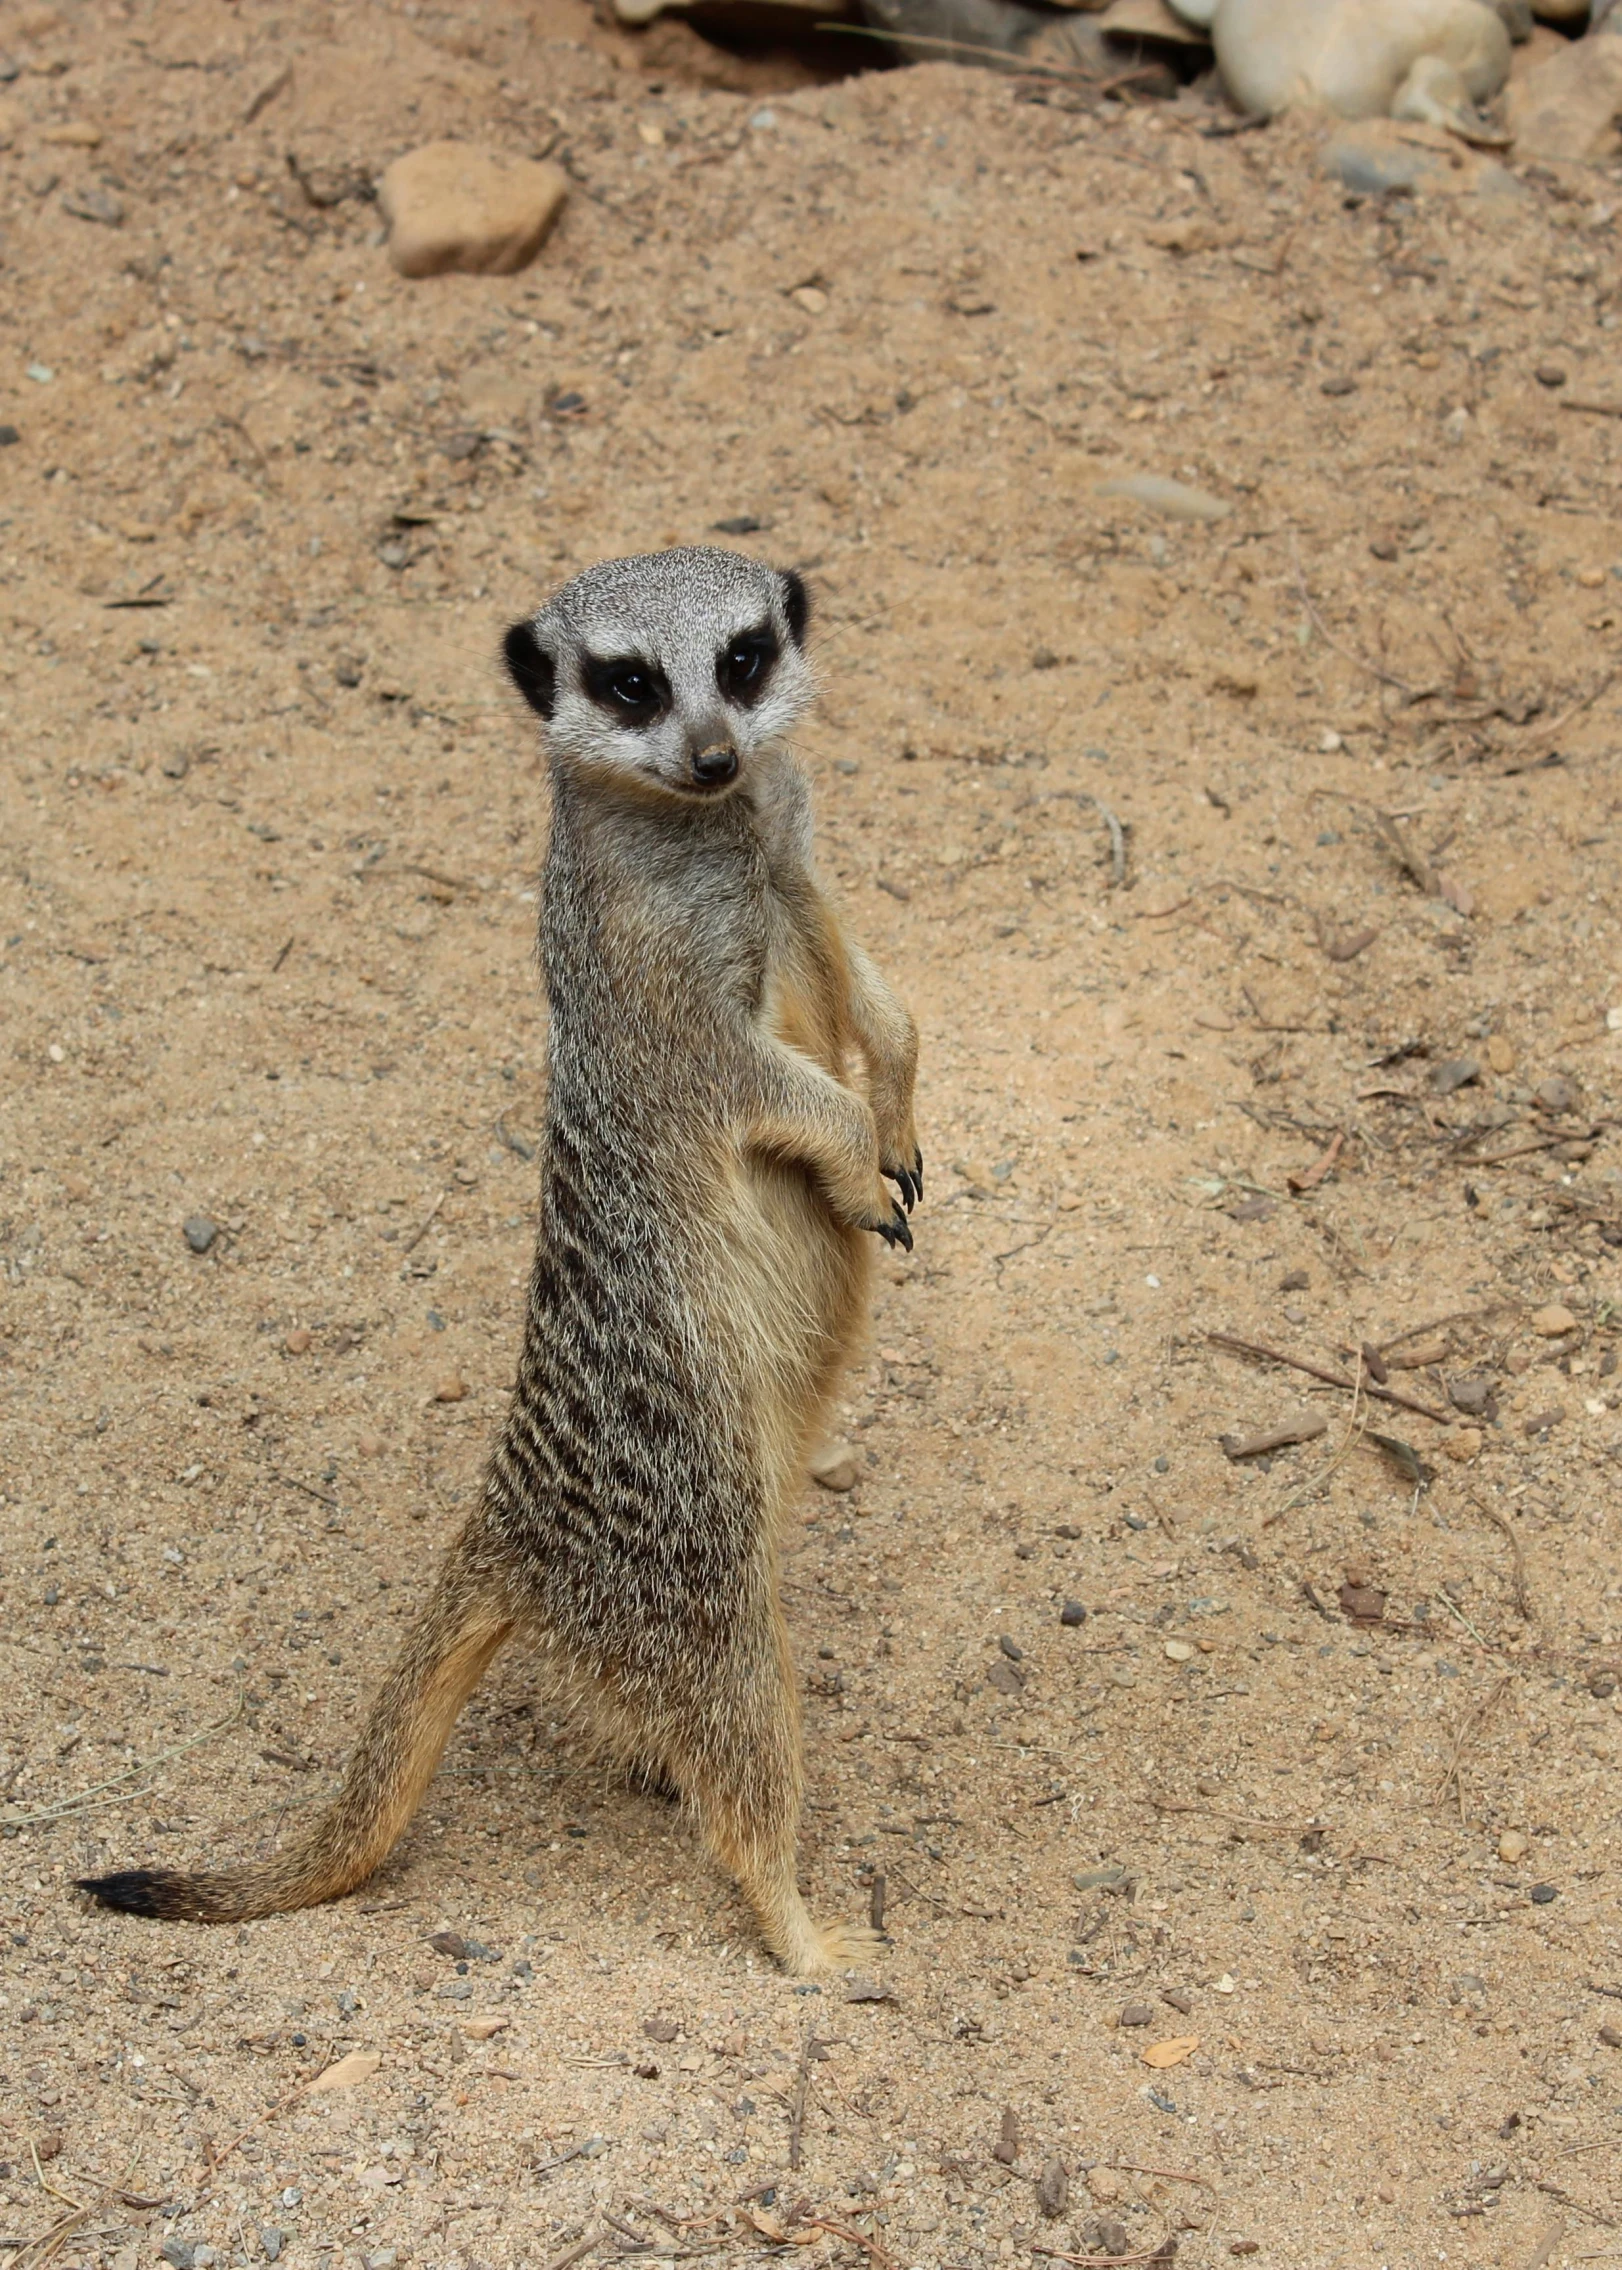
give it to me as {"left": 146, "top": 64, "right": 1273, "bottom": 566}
{"left": 671, "top": 1596, "right": 878, "bottom": 1977}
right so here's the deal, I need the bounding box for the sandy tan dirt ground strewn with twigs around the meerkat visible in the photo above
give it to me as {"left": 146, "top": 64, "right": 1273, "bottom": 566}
{"left": 0, "top": 0, "right": 1622, "bottom": 2270}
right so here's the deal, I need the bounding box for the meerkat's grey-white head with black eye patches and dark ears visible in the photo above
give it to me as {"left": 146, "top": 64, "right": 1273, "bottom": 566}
{"left": 504, "top": 545, "right": 812, "bottom": 799}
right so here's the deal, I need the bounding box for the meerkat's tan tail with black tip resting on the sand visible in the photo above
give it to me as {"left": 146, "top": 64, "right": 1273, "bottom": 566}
{"left": 79, "top": 1537, "right": 515, "bottom": 1923}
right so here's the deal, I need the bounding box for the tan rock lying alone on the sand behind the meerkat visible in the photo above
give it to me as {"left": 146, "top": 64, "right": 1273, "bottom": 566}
{"left": 377, "top": 141, "right": 569, "bottom": 277}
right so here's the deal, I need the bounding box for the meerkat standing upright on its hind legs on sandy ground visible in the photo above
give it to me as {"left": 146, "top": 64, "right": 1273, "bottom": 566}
{"left": 84, "top": 547, "right": 923, "bottom": 1973}
